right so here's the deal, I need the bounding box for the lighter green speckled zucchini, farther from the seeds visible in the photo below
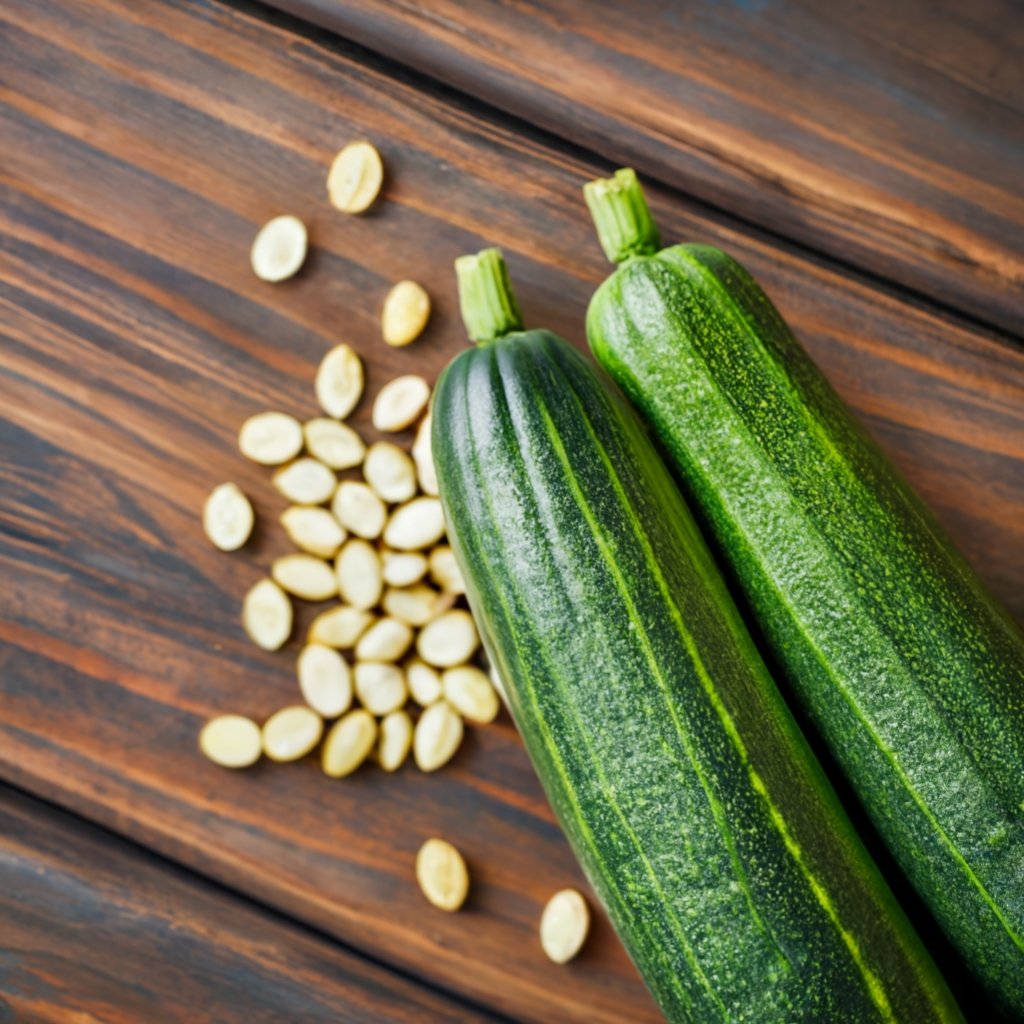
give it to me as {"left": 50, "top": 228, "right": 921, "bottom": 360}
{"left": 585, "top": 170, "right": 1024, "bottom": 1020}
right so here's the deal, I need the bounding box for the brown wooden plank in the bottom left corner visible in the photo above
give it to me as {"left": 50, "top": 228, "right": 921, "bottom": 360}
{"left": 0, "top": 786, "right": 496, "bottom": 1024}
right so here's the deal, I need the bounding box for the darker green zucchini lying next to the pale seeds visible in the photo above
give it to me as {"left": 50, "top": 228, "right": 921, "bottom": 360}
{"left": 432, "top": 250, "right": 962, "bottom": 1024}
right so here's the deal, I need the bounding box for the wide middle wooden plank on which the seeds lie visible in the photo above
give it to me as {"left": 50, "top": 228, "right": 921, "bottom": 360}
{"left": 0, "top": 0, "right": 1024, "bottom": 1022}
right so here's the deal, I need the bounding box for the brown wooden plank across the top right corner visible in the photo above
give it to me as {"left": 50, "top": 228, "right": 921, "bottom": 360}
{"left": 270, "top": 0, "right": 1024, "bottom": 335}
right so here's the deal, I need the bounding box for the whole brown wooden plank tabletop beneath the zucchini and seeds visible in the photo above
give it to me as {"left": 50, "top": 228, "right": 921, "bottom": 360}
{"left": 0, "top": 0, "right": 1024, "bottom": 1024}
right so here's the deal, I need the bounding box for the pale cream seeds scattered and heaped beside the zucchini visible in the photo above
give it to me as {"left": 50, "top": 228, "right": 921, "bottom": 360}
{"left": 199, "top": 142, "right": 590, "bottom": 964}
